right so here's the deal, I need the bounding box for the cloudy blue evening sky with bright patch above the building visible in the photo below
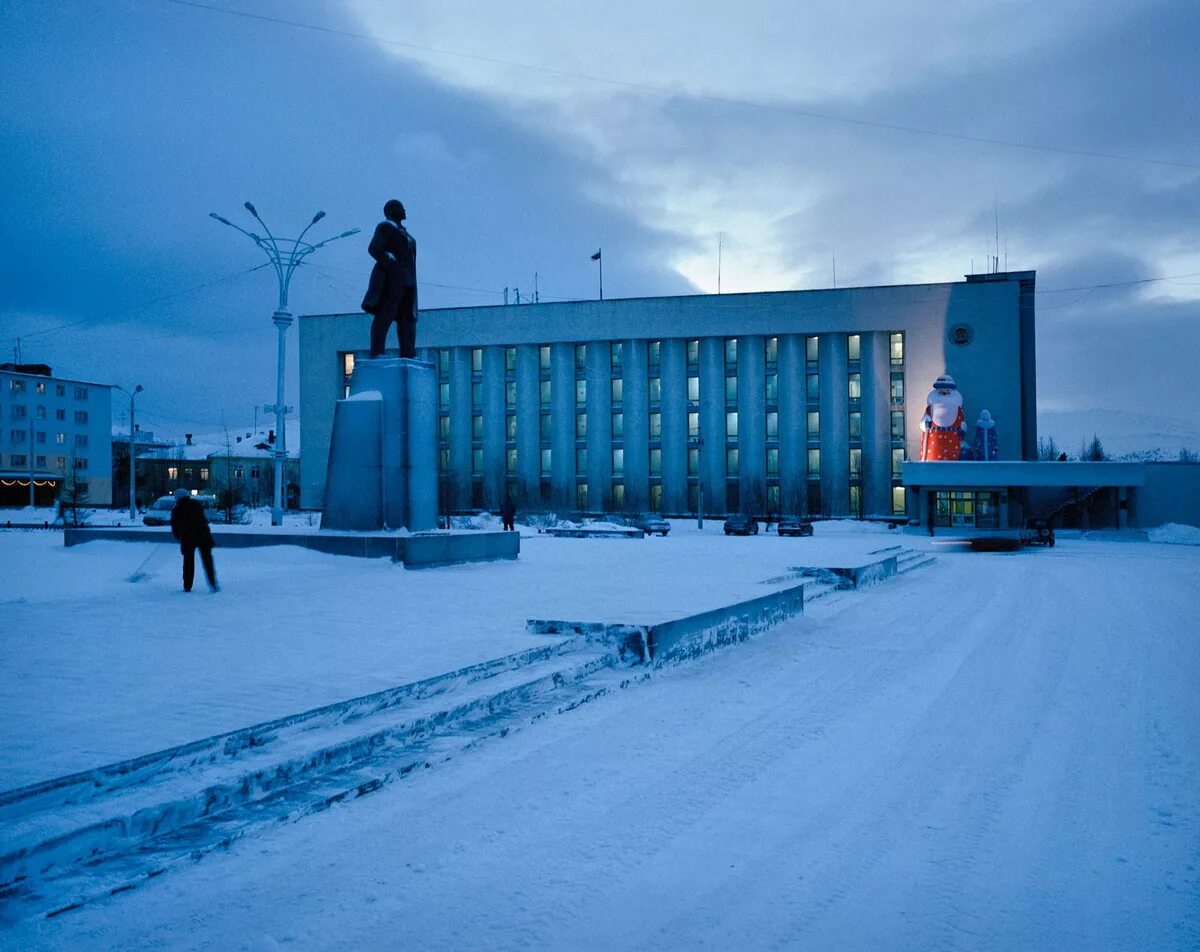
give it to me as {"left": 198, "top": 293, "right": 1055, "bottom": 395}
{"left": 0, "top": 0, "right": 1200, "bottom": 436}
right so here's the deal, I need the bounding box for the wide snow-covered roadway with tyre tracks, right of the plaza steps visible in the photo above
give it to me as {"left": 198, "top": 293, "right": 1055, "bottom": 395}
{"left": 0, "top": 523, "right": 1200, "bottom": 950}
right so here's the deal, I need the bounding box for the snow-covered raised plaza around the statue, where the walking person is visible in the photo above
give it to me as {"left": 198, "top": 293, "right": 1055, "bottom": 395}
{"left": 0, "top": 521, "right": 895, "bottom": 790}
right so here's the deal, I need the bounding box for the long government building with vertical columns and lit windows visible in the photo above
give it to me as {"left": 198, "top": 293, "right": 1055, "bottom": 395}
{"left": 300, "top": 271, "right": 1037, "bottom": 519}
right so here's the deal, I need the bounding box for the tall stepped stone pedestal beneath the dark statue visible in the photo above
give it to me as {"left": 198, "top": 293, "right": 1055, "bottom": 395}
{"left": 320, "top": 358, "right": 438, "bottom": 532}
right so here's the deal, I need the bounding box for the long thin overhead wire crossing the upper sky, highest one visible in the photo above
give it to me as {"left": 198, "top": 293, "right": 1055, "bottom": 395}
{"left": 167, "top": 0, "right": 1200, "bottom": 170}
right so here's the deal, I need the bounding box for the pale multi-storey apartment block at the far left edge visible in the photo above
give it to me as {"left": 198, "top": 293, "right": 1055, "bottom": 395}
{"left": 0, "top": 364, "right": 113, "bottom": 505}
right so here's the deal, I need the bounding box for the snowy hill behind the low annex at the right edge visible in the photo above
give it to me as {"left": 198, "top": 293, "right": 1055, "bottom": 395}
{"left": 1038, "top": 409, "right": 1200, "bottom": 460}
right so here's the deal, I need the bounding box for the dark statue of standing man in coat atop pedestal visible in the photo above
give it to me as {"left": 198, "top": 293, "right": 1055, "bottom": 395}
{"left": 362, "top": 198, "right": 416, "bottom": 357}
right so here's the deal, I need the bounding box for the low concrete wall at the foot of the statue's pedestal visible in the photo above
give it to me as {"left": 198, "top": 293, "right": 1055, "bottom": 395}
{"left": 62, "top": 527, "right": 521, "bottom": 568}
